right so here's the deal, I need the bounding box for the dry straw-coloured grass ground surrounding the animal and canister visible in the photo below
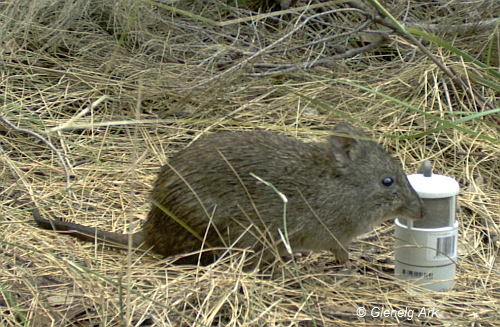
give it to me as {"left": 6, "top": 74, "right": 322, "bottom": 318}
{"left": 0, "top": 0, "right": 500, "bottom": 326}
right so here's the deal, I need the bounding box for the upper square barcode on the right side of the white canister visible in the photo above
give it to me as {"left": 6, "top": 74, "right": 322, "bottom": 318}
{"left": 426, "top": 230, "right": 457, "bottom": 261}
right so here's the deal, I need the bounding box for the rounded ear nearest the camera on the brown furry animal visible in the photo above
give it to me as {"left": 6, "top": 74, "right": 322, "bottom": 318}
{"left": 329, "top": 123, "right": 366, "bottom": 163}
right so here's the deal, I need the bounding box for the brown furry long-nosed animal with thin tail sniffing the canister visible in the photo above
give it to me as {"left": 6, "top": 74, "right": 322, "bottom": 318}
{"left": 35, "top": 124, "right": 424, "bottom": 263}
